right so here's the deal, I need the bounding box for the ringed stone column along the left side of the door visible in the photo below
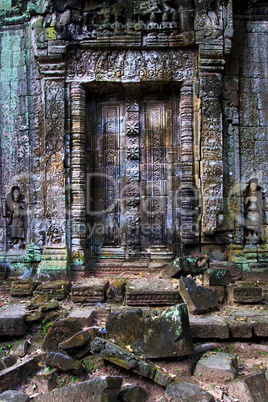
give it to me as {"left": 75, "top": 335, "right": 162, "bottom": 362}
{"left": 71, "top": 83, "right": 86, "bottom": 265}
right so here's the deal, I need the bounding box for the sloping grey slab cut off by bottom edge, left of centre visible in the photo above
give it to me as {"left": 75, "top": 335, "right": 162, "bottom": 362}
{"left": 31, "top": 376, "right": 123, "bottom": 402}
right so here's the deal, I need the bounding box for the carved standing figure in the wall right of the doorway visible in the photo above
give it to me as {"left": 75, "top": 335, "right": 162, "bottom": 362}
{"left": 244, "top": 178, "right": 264, "bottom": 242}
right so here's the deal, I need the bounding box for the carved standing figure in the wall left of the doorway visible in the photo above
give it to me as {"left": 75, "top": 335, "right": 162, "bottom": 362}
{"left": 7, "top": 186, "right": 26, "bottom": 248}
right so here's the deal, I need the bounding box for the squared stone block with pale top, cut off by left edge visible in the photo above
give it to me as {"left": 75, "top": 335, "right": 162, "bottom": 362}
{"left": 0, "top": 303, "right": 26, "bottom": 337}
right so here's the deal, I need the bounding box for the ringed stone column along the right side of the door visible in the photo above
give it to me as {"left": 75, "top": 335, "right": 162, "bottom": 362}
{"left": 180, "top": 81, "right": 197, "bottom": 244}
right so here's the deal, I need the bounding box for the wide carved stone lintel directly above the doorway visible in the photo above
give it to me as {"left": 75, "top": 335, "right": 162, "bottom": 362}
{"left": 67, "top": 50, "right": 197, "bottom": 82}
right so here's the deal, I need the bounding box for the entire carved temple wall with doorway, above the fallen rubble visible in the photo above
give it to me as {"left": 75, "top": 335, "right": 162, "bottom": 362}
{"left": 0, "top": 0, "right": 268, "bottom": 276}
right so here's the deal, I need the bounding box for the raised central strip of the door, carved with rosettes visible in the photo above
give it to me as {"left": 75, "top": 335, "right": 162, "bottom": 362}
{"left": 125, "top": 99, "right": 140, "bottom": 248}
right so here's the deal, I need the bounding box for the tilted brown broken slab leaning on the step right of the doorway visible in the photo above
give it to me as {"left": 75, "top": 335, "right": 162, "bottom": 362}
{"left": 179, "top": 278, "right": 218, "bottom": 314}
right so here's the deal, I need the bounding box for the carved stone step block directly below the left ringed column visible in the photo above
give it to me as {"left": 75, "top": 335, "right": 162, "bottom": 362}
{"left": 71, "top": 278, "right": 109, "bottom": 303}
